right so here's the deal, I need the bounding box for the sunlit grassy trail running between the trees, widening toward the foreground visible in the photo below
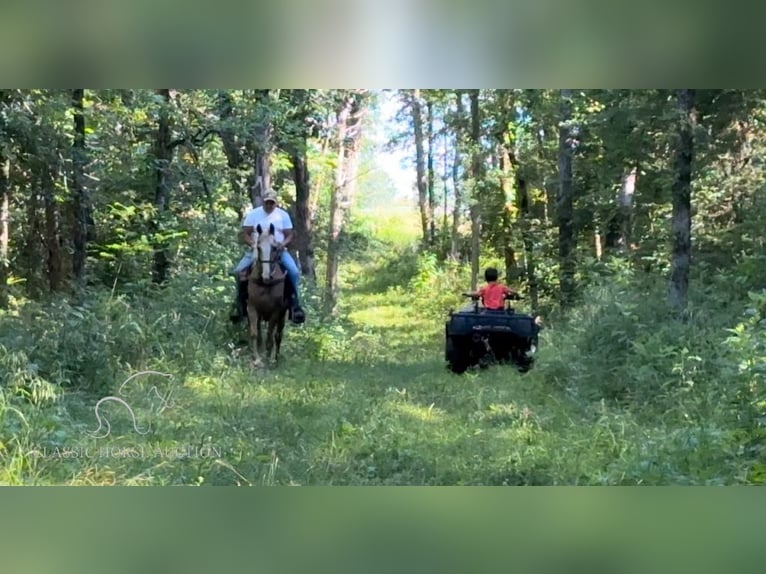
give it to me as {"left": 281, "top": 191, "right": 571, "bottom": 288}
{"left": 5, "top": 258, "right": 608, "bottom": 485}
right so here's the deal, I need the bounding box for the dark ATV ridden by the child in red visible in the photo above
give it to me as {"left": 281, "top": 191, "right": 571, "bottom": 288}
{"left": 444, "top": 293, "right": 542, "bottom": 374}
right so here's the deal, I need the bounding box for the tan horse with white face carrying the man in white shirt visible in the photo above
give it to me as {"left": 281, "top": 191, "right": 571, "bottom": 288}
{"left": 247, "top": 225, "right": 289, "bottom": 366}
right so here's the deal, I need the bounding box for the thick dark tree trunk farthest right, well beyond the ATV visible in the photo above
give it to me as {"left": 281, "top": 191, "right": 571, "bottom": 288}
{"left": 670, "top": 89, "right": 696, "bottom": 309}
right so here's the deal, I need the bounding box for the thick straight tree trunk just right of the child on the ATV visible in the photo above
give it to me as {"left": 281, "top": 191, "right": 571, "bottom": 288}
{"left": 556, "top": 90, "right": 576, "bottom": 308}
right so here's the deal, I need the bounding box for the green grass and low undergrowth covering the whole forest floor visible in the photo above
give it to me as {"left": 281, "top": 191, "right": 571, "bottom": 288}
{"left": 0, "top": 212, "right": 766, "bottom": 485}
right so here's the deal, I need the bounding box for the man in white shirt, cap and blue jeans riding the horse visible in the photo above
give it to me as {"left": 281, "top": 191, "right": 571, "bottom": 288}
{"left": 231, "top": 191, "right": 306, "bottom": 324}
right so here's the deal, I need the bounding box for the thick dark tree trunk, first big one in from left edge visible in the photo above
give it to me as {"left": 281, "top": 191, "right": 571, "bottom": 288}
{"left": 72, "top": 89, "right": 94, "bottom": 281}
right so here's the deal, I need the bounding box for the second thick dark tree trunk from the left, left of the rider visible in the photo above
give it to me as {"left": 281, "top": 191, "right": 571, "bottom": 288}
{"left": 152, "top": 89, "right": 173, "bottom": 284}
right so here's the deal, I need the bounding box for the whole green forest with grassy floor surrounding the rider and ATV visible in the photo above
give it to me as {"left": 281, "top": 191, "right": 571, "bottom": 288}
{"left": 0, "top": 89, "right": 766, "bottom": 486}
